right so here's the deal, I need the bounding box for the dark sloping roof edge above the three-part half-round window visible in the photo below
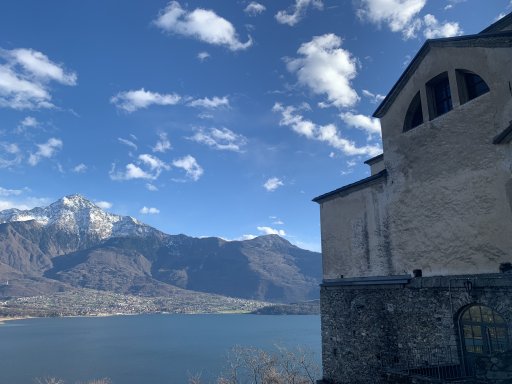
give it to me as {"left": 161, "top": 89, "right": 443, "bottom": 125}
{"left": 373, "top": 30, "right": 512, "bottom": 118}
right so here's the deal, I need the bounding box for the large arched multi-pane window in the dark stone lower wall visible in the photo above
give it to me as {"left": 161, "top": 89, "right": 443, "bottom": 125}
{"left": 459, "top": 305, "right": 510, "bottom": 372}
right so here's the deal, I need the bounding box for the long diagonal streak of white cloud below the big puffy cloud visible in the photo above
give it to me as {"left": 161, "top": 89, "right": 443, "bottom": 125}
{"left": 273, "top": 103, "right": 382, "bottom": 156}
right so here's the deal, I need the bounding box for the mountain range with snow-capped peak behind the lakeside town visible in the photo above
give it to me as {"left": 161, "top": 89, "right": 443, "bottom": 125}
{"left": 0, "top": 195, "right": 321, "bottom": 302}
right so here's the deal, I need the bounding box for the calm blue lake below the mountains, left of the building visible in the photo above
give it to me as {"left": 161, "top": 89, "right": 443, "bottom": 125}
{"left": 0, "top": 315, "right": 321, "bottom": 384}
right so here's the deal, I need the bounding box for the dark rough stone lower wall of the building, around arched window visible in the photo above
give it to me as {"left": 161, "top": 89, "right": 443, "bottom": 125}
{"left": 321, "top": 273, "right": 512, "bottom": 384}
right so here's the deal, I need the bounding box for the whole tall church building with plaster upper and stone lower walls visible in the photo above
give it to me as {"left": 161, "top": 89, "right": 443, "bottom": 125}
{"left": 313, "top": 14, "right": 512, "bottom": 384}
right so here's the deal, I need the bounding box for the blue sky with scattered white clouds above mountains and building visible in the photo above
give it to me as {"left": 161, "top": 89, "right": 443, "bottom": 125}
{"left": 0, "top": 0, "right": 512, "bottom": 250}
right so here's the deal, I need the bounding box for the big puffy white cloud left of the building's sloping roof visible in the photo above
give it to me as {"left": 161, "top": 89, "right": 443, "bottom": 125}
{"left": 287, "top": 33, "right": 359, "bottom": 107}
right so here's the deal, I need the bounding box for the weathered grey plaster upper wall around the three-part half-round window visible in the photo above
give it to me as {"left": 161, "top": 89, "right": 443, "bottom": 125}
{"left": 321, "top": 42, "right": 512, "bottom": 278}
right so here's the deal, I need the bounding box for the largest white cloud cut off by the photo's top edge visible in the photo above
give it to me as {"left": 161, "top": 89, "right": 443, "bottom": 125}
{"left": 356, "top": 0, "right": 427, "bottom": 38}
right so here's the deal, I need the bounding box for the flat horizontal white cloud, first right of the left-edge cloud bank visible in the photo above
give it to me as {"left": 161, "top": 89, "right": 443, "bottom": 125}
{"left": 110, "top": 88, "right": 181, "bottom": 113}
